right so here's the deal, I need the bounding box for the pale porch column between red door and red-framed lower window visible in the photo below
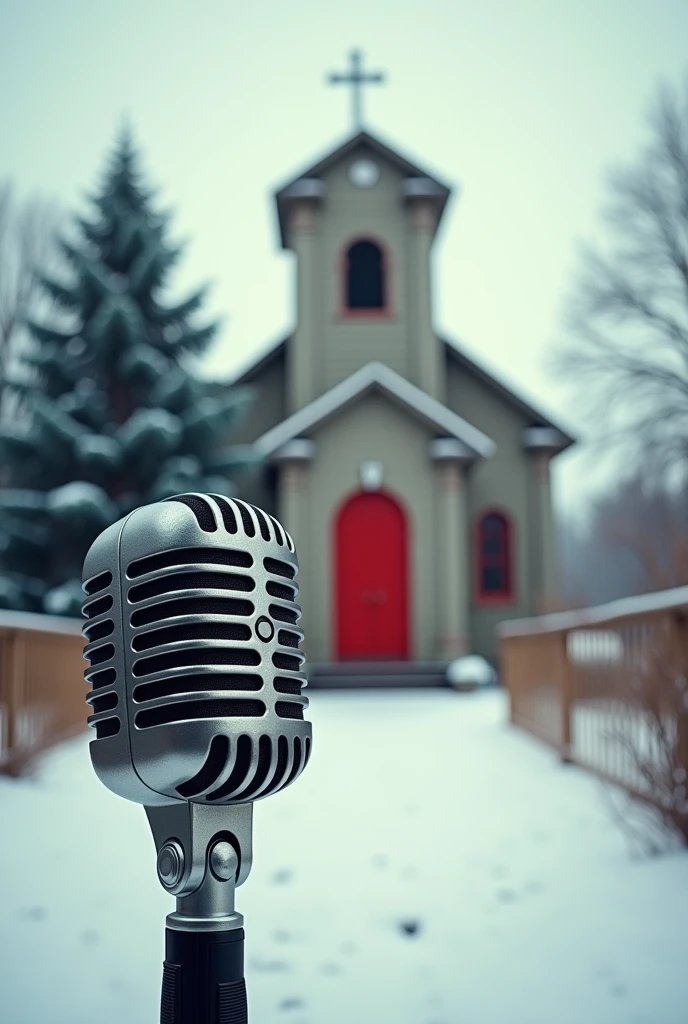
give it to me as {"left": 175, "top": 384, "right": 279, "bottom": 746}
{"left": 431, "top": 438, "right": 471, "bottom": 660}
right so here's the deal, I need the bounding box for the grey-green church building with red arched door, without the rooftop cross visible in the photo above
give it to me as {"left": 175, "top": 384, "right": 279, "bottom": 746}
{"left": 228, "top": 131, "right": 573, "bottom": 665}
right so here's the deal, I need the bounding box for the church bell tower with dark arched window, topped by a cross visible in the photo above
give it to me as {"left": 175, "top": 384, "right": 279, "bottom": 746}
{"left": 275, "top": 54, "right": 449, "bottom": 413}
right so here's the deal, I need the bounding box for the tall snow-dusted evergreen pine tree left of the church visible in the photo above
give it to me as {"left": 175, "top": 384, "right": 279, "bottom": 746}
{"left": 0, "top": 132, "right": 253, "bottom": 615}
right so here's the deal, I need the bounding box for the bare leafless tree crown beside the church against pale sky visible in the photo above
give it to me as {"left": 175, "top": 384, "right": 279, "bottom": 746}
{"left": 553, "top": 72, "right": 688, "bottom": 479}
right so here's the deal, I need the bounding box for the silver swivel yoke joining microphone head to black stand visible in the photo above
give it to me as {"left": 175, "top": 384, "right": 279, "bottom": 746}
{"left": 145, "top": 801, "right": 253, "bottom": 932}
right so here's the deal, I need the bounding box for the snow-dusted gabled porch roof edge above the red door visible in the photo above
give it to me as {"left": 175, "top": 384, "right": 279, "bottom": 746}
{"left": 255, "top": 362, "right": 497, "bottom": 459}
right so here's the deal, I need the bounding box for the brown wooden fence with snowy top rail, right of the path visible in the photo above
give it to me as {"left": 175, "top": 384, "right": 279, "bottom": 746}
{"left": 499, "top": 587, "right": 688, "bottom": 806}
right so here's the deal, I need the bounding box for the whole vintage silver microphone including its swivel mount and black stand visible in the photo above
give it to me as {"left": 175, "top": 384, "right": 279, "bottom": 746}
{"left": 83, "top": 494, "right": 311, "bottom": 1024}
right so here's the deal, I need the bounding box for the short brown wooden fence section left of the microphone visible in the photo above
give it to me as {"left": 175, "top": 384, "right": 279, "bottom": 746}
{"left": 0, "top": 611, "right": 88, "bottom": 774}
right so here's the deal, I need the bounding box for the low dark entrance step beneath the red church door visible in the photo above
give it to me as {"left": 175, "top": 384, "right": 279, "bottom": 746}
{"left": 307, "top": 662, "right": 447, "bottom": 689}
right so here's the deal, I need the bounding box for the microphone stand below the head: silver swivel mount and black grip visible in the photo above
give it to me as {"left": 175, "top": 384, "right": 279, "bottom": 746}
{"left": 145, "top": 801, "right": 253, "bottom": 1024}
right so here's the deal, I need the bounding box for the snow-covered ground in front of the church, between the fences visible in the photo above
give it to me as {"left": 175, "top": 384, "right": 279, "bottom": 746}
{"left": 0, "top": 689, "right": 688, "bottom": 1024}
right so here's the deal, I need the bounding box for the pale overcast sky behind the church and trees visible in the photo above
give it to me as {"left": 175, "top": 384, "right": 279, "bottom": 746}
{"left": 0, "top": 0, "right": 688, "bottom": 505}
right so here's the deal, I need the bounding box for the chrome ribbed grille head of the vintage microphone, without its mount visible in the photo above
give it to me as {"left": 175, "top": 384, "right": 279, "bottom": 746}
{"left": 83, "top": 494, "right": 311, "bottom": 806}
